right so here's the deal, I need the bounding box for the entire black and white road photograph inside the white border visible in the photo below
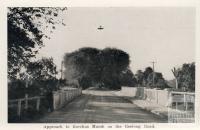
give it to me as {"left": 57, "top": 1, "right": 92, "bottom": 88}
{"left": 7, "top": 6, "right": 197, "bottom": 124}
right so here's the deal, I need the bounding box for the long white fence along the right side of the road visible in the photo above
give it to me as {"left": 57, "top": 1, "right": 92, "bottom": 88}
{"left": 121, "top": 87, "right": 195, "bottom": 111}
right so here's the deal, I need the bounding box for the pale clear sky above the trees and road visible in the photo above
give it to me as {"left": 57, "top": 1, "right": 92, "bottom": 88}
{"left": 37, "top": 7, "right": 195, "bottom": 80}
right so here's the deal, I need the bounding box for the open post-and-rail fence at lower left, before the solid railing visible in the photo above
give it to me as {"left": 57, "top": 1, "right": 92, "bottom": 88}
{"left": 8, "top": 95, "right": 44, "bottom": 117}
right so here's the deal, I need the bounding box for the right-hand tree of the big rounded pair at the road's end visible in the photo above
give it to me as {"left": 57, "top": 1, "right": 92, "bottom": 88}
{"left": 100, "top": 48, "right": 130, "bottom": 89}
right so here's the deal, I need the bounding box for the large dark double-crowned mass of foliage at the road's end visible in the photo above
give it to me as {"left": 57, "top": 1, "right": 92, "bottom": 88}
{"left": 64, "top": 47, "right": 134, "bottom": 89}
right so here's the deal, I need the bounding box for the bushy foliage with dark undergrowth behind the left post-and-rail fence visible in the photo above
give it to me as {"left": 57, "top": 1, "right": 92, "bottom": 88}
{"left": 9, "top": 58, "right": 58, "bottom": 99}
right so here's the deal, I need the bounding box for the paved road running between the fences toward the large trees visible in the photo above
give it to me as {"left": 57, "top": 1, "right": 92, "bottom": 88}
{"left": 37, "top": 88, "right": 167, "bottom": 123}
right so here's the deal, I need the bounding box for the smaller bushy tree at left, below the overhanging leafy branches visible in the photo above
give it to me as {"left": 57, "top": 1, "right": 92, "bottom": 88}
{"left": 20, "top": 58, "right": 59, "bottom": 96}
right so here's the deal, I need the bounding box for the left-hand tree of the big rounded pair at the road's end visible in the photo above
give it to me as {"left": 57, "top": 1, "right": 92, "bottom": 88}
{"left": 64, "top": 47, "right": 100, "bottom": 88}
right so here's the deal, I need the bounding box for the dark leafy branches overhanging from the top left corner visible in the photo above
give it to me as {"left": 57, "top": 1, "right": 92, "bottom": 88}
{"left": 7, "top": 7, "right": 66, "bottom": 79}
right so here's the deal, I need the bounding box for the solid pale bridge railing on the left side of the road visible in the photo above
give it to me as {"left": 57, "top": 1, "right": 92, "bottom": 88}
{"left": 53, "top": 88, "right": 82, "bottom": 110}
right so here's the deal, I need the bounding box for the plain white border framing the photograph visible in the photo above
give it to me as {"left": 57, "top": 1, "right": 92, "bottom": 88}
{"left": 0, "top": 0, "right": 200, "bottom": 130}
